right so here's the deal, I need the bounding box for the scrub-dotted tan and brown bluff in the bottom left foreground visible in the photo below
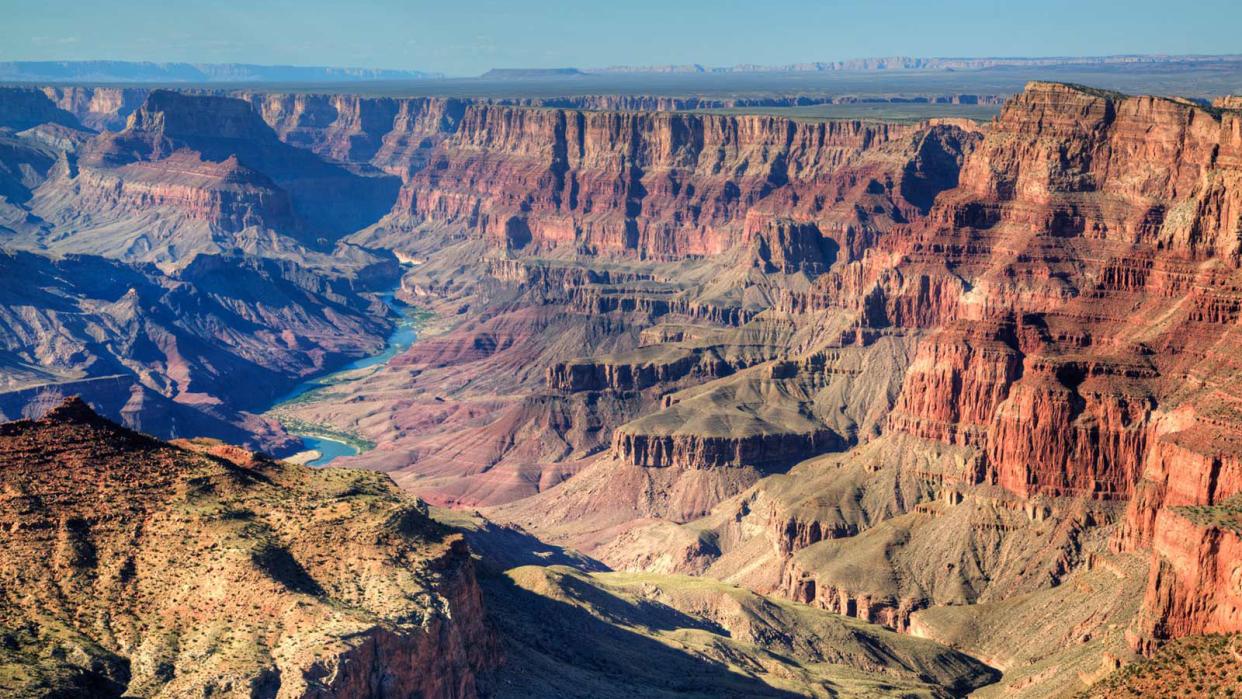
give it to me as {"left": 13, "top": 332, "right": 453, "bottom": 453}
{"left": 0, "top": 401, "right": 496, "bottom": 698}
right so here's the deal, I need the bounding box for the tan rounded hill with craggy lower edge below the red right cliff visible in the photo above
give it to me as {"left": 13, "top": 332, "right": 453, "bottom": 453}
{"left": 777, "top": 486, "right": 1108, "bottom": 631}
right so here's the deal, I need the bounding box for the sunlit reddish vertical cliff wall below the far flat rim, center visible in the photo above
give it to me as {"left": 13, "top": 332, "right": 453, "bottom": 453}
{"left": 397, "top": 104, "right": 965, "bottom": 260}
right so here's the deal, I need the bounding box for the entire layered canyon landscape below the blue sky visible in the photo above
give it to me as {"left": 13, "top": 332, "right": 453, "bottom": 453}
{"left": 0, "top": 21, "right": 1242, "bottom": 699}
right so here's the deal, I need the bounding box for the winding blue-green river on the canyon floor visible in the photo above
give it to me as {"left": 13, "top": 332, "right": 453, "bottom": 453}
{"left": 267, "top": 293, "right": 425, "bottom": 467}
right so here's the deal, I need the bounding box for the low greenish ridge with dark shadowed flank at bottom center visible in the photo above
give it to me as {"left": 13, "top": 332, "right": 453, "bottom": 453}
{"left": 481, "top": 566, "right": 999, "bottom": 698}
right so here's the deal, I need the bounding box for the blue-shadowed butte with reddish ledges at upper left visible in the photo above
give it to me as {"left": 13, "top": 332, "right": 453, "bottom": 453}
{"left": 31, "top": 91, "right": 396, "bottom": 262}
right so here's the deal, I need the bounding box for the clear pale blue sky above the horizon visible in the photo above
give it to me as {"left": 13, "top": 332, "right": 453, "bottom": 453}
{"left": 0, "top": 0, "right": 1242, "bottom": 74}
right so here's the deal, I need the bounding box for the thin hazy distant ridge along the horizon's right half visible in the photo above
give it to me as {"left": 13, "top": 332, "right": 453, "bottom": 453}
{"left": 584, "top": 53, "right": 1242, "bottom": 73}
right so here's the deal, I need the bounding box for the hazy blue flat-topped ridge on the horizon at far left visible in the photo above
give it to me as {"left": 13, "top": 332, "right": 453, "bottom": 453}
{"left": 0, "top": 61, "right": 443, "bottom": 83}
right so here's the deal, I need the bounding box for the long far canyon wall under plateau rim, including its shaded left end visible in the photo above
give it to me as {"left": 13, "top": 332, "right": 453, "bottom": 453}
{"left": 226, "top": 93, "right": 975, "bottom": 264}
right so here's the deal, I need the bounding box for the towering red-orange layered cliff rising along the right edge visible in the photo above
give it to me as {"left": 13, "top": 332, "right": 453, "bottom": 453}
{"left": 809, "top": 83, "right": 1242, "bottom": 647}
